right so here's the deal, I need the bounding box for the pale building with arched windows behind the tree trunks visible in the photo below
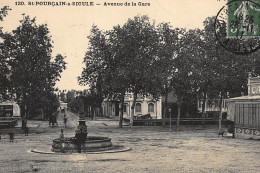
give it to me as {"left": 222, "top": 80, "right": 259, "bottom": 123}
{"left": 102, "top": 93, "right": 162, "bottom": 119}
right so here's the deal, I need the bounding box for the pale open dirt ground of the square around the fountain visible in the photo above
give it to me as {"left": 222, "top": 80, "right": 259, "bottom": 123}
{"left": 0, "top": 112, "right": 260, "bottom": 173}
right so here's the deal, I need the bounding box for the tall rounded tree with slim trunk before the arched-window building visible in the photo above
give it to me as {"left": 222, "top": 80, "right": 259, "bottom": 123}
{"left": 114, "top": 16, "right": 159, "bottom": 128}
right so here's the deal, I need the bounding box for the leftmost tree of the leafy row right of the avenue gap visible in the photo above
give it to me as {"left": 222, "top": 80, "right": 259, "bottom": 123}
{"left": 78, "top": 25, "right": 111, "bottom": 114}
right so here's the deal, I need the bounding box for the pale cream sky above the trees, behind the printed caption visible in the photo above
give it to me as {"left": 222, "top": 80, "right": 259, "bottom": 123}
{"left": 0, "top": 0, "right": 226, "bottom": 90}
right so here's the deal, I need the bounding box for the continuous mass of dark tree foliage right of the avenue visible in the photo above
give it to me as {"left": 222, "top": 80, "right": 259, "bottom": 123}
{"left": 79, "top": 16, "right": 260, "bottom": 129}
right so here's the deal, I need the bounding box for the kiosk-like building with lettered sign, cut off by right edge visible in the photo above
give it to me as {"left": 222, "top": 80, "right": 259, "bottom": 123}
{"left": 228, "top": 75, "right": 260, "bottom": 139}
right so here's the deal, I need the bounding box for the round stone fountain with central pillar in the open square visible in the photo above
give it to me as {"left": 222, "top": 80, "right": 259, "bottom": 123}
{"left": 52, "top": 118, "right": 113, "bottom": 153}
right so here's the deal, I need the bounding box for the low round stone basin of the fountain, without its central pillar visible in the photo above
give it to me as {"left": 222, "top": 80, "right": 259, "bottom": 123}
{"left": 52, "top": 136, "right": 112, "bottom": 152}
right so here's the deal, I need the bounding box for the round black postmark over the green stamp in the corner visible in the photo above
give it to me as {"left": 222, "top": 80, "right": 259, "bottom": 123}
{"left": 215, "top": 0, "right": 260, "bottom": 54}
